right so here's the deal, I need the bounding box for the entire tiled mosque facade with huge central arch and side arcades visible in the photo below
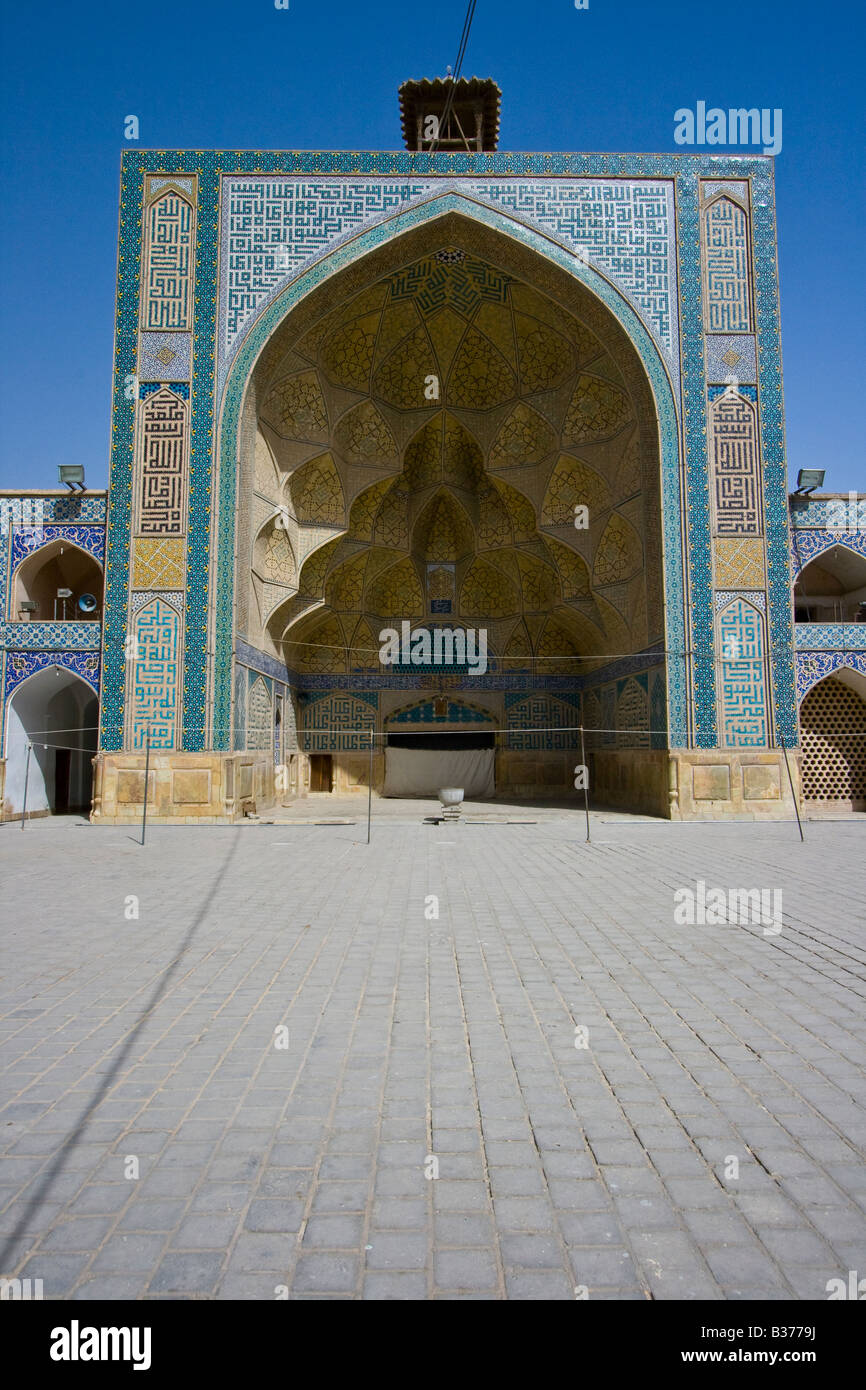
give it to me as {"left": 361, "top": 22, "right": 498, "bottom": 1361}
{"left": 0, "top": 86, "right": 866, "bottom": 823}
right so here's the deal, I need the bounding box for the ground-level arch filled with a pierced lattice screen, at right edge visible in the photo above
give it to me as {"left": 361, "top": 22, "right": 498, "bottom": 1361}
{"left": 799, "top": 669, "right": 866, "bottom": 810}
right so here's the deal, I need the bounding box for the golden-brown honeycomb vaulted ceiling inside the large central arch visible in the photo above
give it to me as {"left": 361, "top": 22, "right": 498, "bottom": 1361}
{"left": 247, "top": 246, "right": 646, "bottom": 674}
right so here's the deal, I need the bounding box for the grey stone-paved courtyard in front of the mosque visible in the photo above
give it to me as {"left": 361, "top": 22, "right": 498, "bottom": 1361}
{"left": 0, "top": 808, "right": 866, "bottom": 1300}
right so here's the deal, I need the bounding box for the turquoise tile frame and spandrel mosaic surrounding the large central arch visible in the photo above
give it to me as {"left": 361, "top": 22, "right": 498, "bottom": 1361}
{"left": 103, "top": 150, "right": 795, "bottom": 749}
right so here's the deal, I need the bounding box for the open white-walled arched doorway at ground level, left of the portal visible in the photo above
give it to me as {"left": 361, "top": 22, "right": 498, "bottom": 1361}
{"left": 3, "top": 666, "right": 99, "bottom": 820}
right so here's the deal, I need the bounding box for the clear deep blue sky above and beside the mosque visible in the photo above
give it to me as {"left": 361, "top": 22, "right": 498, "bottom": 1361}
{"left": 0, "top": 0, "right": 866, "bottom": 491}
